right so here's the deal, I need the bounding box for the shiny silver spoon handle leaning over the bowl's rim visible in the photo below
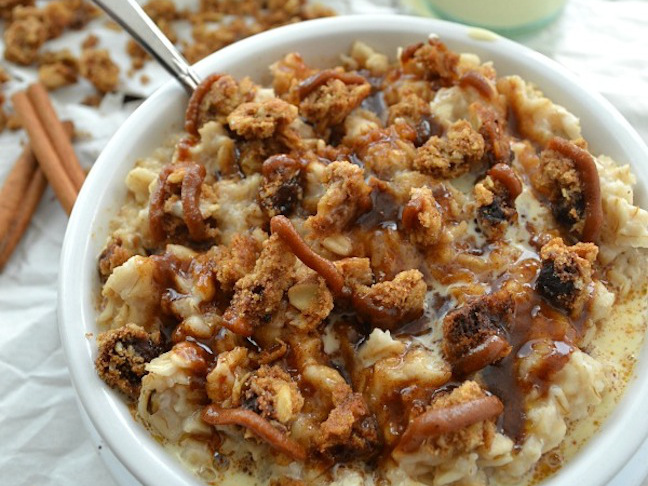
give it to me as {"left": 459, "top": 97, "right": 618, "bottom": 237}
{"left": 92, "top": 0, "right": 200, "bottom": 93}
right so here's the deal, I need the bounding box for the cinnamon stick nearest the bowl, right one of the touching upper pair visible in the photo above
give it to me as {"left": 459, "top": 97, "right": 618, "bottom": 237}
{"left": 27, "top": 83, "right": 85, "bottom": 193}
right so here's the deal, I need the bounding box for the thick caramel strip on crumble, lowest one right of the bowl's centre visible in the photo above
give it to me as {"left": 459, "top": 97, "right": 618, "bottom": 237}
{"left": 396, "top": 395, "right": 504, "bottom": 453}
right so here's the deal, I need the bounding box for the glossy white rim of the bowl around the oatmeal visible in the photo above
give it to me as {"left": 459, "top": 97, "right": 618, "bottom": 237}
{"left": 58, "top": 14, "right": 648, "bottom": 486}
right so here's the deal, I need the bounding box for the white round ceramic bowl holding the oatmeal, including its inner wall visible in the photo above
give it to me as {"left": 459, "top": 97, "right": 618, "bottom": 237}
{"left": 59, "top": 16, "right": 648, "bottom": 486}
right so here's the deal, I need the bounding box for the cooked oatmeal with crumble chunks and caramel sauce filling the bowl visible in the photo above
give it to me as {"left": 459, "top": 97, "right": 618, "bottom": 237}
{"left": 57, "top": 15, "right": 648, "bottom": 485}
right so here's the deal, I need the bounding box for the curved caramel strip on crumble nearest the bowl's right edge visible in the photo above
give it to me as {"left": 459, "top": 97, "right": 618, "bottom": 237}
{"left": 547, "top": 137, "right": 603, "bottom": 242}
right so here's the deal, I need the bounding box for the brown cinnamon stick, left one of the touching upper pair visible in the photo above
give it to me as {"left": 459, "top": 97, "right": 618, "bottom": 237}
{"left": 11, "top": 92, "right": 77, "bottom": 214}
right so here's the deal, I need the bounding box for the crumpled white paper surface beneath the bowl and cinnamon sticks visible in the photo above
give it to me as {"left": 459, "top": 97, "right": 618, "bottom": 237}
{"left": 0, "top": 0, "right": 648, "bottom": 486}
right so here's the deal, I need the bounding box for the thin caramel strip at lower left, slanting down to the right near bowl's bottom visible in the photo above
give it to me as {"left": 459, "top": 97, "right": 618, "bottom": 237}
{"left": 201, "top": 405, "right": 306, "bottom": 461}
